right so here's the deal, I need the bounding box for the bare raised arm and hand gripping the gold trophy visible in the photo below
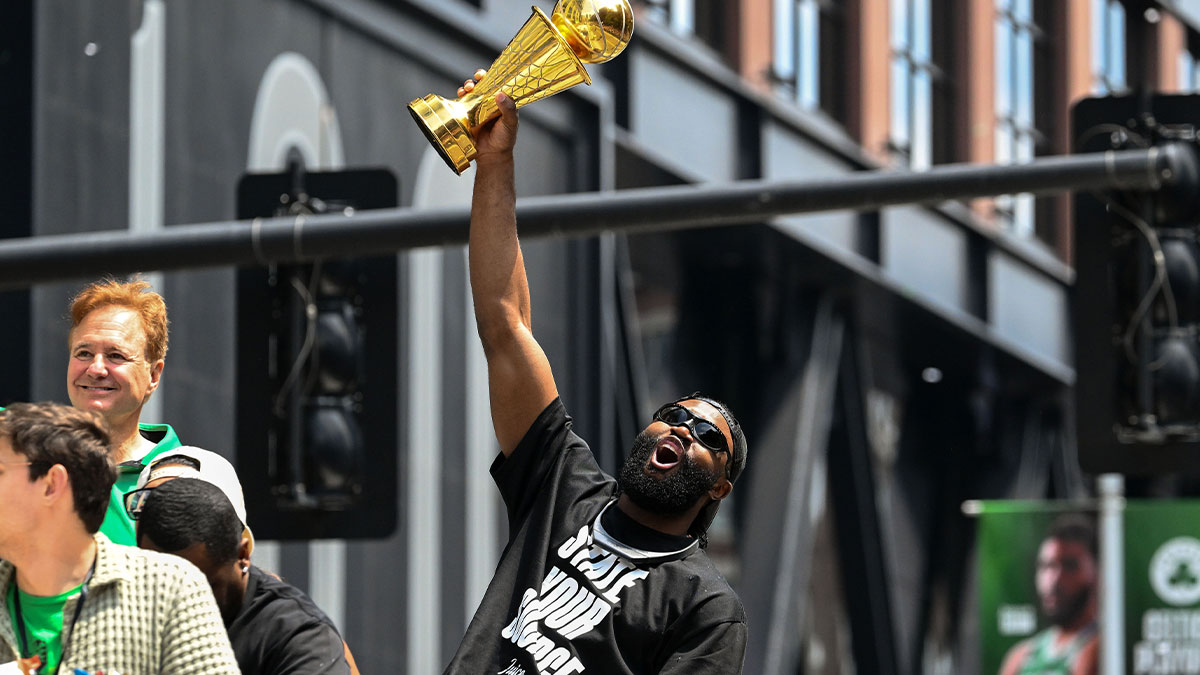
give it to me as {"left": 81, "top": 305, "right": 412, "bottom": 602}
{"left": 464, "top": 73, "right": 558, "bottom": 456}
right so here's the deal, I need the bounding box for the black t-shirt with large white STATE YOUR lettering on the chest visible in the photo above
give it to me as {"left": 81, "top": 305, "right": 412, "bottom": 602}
{"left": 445, "top": 400, "right": 746, "bottom": 675}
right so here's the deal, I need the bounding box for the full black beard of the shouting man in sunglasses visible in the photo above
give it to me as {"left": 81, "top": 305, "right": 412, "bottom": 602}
{"left": 617, "top": 431, "right": 718, "bottom": 515}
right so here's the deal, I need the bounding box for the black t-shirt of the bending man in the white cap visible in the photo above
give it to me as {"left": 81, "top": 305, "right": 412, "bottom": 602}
{"left": 229, "top": 565, "right": 350, "bottom": 675}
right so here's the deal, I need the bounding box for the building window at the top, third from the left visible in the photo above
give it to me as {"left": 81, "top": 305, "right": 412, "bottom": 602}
{"left": 890, "top": 0, "right": 944, "bottom": 169}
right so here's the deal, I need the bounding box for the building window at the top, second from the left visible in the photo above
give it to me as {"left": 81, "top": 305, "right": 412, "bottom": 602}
{"left": 770, "top": 0, "right": 845, "bottom": 121}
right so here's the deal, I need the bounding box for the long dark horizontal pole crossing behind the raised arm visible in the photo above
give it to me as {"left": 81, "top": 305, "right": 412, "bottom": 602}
{"left": 0, "top": 143, "right": 1200, "bottom": 288}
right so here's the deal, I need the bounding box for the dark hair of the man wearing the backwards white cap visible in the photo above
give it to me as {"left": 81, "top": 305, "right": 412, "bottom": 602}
{"left": 138, "top": 478, "right": 242, "bottom": 565}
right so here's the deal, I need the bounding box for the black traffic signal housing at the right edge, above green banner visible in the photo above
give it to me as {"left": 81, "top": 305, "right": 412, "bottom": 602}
{"left": 1072, "top": 94, "right": 1200, "bottom": 476}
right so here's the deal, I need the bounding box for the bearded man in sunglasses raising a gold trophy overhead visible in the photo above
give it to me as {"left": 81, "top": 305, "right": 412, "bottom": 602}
{"left": 446, "top": 72, "right": 746, "bottom": 675}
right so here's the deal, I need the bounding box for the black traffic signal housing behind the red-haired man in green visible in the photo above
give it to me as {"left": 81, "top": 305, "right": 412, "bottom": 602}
{"left": 236, "top": 166, "right": 397, "bottom": 539}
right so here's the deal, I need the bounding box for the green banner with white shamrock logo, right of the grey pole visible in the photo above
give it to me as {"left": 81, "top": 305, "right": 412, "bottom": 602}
{"left": 1124, "top": 500, "right": 1200, "bottom": 675}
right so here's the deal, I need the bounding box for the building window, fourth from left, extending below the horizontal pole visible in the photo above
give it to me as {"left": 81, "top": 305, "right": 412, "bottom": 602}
{"left": 996, "top": 0, "right": 1048, "bottom": 237}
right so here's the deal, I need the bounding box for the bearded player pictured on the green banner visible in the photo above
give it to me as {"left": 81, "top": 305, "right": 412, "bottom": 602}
{"left": 1001, "top": 514, "right": 1100, "bottom": 675}
